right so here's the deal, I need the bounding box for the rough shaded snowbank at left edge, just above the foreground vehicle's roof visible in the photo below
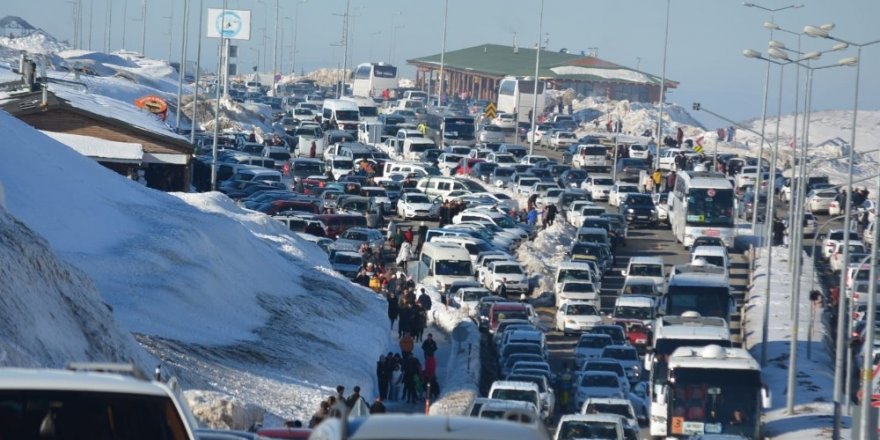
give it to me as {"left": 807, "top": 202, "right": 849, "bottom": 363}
{"left": 0, "top": 205, "right": 150, "bottom": 368}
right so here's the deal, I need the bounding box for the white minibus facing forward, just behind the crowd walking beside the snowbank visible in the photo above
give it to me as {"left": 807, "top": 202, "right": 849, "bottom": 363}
{"left": 416, "top": 242, "right": 476, "bottom": 291}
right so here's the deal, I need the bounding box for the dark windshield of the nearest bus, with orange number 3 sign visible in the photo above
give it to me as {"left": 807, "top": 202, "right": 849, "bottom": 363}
{"left": 669, "top": 367, "right": 761, "bottom": 436}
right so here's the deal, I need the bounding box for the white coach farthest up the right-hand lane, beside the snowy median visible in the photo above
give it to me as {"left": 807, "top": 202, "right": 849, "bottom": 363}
{"left": 667, "top": 171, "right": 736, "bottom": 248}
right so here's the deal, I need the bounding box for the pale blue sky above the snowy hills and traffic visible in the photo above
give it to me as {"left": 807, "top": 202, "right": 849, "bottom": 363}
{"left": 6, "top": 0, "right": 880, "bottom": 127}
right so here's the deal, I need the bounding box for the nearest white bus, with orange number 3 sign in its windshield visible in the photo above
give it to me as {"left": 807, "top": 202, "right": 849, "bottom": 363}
{"left": 651, "top": 344, "right": 770, "bottom": 439}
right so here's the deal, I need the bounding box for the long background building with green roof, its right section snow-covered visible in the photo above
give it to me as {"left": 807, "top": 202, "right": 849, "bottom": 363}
{"left": 407, "top": 43, "right": 678, "bottom": 102}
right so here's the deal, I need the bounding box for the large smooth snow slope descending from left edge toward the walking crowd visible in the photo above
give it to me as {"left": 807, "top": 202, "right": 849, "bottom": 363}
{"left": 0, "top": 114, "right": 387, "bottom": 419}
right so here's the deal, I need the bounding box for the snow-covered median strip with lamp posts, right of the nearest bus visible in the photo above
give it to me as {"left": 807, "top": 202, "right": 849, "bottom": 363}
{"left": 744, "top": 247, "right": 849, "bottom": 439}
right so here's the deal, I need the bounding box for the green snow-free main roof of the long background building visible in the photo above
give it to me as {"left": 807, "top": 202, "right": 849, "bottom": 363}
{"left": 407, "top": 43, "right": 583, "bottom": 78}
